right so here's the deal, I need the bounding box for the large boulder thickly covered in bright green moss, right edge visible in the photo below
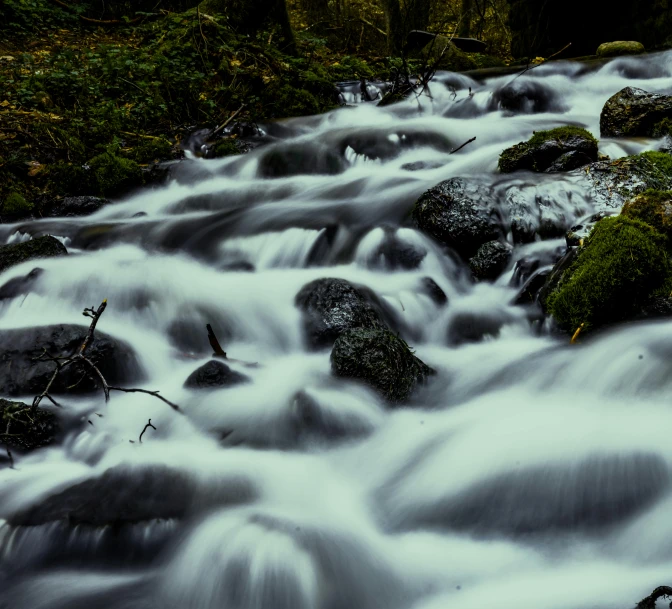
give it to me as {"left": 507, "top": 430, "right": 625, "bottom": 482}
{"left": 547, "top": 216, "right": 670, "bottom": 333}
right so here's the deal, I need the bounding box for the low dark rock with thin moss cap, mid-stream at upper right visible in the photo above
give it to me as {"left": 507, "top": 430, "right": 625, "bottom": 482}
{"left": 499, "top": 125, "right": 597, "bottom": 173}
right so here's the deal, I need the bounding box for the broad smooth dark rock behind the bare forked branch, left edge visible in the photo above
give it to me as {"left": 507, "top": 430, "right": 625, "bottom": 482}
{"left": 0, "top": 324, "right": 142, "bottom": 396}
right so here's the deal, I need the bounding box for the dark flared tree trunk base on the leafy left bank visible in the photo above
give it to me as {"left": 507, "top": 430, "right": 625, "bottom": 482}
{"left": 199, "top": 0, "right": 296, "bottom": 53}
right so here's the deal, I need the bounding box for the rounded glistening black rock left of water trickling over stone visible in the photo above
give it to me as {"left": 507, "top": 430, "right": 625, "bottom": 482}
{"left": 413, "top": 178, "right": 502, "bottom": 259}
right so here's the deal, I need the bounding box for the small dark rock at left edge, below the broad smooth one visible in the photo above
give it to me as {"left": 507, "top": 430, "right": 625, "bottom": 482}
{"left": 0, "top": 399, "right": 59, "bottom": 451}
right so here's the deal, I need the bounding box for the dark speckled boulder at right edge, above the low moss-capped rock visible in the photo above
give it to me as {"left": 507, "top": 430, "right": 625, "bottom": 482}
{"left": 600, "top": 87, "right": 672, "bottom": 137}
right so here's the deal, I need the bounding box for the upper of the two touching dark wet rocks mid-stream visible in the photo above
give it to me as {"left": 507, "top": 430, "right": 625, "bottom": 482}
{"left": 295, "top": 279, "right": 386, "bottom": 349}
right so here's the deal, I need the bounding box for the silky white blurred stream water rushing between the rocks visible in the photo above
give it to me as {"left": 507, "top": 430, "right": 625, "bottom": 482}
{"left": 0, "top": 54, "right": 672, "bottom": 609}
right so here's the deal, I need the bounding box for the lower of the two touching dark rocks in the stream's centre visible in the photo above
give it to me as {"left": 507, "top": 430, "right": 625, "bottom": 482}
{"left": 331, "top": 329, "right": 434, "bottom": 404}
